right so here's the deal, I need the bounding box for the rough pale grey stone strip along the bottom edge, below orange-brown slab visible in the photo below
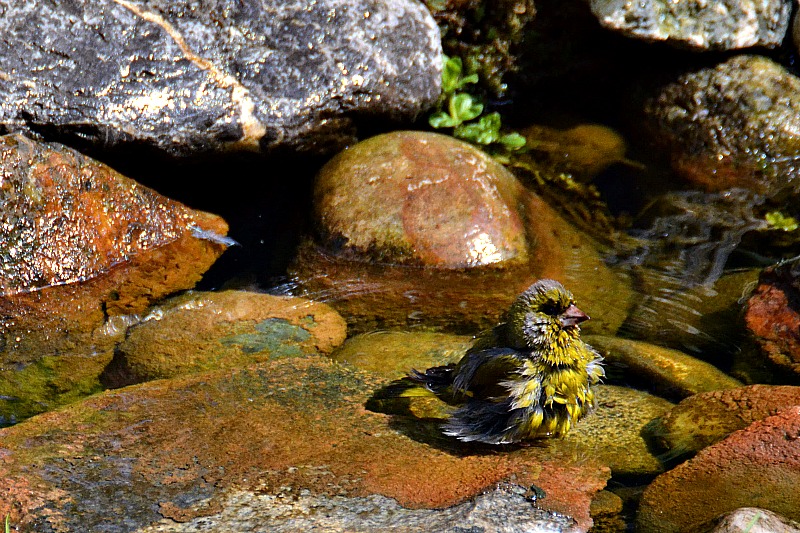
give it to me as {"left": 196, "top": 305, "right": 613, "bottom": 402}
{"left": 139, "top": 484, "right": 580, "bottom": 533}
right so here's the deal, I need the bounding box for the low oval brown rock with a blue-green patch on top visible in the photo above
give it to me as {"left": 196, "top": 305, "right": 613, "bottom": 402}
{"left": 108, "top": 291, "right": 347, "bottom": 385}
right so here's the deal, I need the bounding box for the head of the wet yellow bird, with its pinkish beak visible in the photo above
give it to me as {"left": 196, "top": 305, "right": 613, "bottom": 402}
{"left": 506, "top": 279, "right": 589, "bottom": 350}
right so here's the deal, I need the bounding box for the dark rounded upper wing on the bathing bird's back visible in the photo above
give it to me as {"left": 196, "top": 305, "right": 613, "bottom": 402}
{"left": 453, "top": 348, "right": 524, "bottom": 398}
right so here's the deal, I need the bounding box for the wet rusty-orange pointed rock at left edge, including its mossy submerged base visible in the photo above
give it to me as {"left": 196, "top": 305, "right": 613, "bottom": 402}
{"left": 0, "top": 135, "right": 228, "bottom": 425}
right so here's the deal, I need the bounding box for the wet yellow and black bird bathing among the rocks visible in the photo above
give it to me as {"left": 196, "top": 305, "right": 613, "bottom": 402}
{"left": 407, "top": 279, "right": 605, "bottom": 444}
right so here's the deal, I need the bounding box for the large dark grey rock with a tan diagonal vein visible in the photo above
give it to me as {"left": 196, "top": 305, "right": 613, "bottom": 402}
{"left": 0, "top": 0, "right": 441, "bottom": 155}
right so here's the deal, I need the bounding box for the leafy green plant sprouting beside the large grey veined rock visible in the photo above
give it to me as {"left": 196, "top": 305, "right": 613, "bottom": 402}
{"left": 428, "top": 55, "right": 526, "bottom": 152}
